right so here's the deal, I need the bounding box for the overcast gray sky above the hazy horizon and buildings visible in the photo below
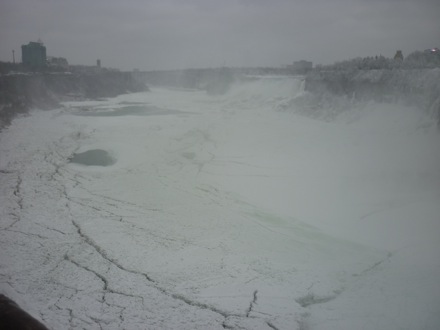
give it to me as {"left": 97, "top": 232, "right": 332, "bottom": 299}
{"left": 0, "top": 0, "right": 440, "bottom": 70}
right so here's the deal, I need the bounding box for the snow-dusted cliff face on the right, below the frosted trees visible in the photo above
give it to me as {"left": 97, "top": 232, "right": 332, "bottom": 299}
{"left": 305, "top": 68, "right": 440, "bottom": 123}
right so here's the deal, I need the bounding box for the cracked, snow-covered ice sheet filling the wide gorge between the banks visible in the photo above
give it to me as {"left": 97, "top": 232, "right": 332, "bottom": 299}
{"left": 0, "top": 77, "right": 440, "bottom": 330}
